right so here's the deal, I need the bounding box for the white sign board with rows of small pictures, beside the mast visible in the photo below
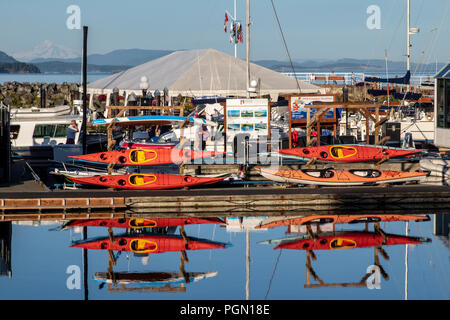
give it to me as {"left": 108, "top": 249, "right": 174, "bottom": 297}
{"left": 225, "top": 99, "right": 270, "bottom": 137}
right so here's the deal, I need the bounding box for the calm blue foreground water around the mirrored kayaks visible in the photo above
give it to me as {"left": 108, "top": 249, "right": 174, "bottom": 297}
{"left": 0, "top": 214, "right": 450, "bottom": 300}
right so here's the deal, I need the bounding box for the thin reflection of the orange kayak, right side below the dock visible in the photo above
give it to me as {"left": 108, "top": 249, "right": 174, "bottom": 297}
{"left": 257, "top": 214, "right": 430, "bottom": 229}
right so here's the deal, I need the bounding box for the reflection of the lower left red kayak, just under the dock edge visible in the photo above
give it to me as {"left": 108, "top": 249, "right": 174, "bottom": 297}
{"left": 62, "top": 217, "right": 226, "bottom": 230}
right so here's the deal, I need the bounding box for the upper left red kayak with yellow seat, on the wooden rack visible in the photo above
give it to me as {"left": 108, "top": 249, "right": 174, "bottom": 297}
{"left": 70, "top": 148, "right": 222, "bottom": 166}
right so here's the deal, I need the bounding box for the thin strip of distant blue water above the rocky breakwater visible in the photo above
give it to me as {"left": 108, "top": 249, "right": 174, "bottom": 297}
{"left": 0, "top": 73, "right": 111, "bottom": 84}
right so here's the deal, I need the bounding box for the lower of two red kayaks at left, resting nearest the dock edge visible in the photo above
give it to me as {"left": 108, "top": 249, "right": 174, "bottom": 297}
{"left": 67, "top": 173, "right": 227, "bottom": 190}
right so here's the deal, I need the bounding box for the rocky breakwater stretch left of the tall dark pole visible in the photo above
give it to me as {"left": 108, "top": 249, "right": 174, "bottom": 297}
{"left": 0, "top": 81, "right": 81, "bottom": 108}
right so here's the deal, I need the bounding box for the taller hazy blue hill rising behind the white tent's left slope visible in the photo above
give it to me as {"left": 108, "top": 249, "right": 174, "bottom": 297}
{"left": 32, "top": 49, "right": 174, "bottom": 67}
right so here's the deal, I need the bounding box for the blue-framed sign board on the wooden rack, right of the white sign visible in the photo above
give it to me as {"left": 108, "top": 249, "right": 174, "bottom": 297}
{"left": 289, "top": 94, "right": 335, "bottom": 120}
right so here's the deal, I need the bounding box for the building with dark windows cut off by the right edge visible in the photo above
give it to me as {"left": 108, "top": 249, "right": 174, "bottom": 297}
{"left": 434, "top": 63, "right": 450, "bottom": 148}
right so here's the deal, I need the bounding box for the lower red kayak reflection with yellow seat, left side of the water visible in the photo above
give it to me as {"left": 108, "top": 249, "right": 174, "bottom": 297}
{"left": 71, "top": 234, "right": 229, "bottom": 253}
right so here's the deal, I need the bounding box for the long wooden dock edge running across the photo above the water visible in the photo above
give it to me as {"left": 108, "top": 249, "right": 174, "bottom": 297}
{"left": 0, "top": 185, "right": 450, "bottom": 221}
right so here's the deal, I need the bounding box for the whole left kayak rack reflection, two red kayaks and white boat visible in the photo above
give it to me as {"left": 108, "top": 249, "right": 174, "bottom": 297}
{"left": 61, "top": 217, "right": 231, "bottom": 292}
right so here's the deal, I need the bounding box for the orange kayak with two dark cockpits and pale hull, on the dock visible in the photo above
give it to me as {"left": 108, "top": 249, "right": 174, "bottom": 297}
{"left": 260, "top": 168, "right": 427, "bottom": 186}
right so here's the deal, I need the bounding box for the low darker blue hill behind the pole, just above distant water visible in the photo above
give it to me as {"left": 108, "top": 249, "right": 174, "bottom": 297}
{"left": 35, "top": 61, "right": 130, "bottom": 73}
